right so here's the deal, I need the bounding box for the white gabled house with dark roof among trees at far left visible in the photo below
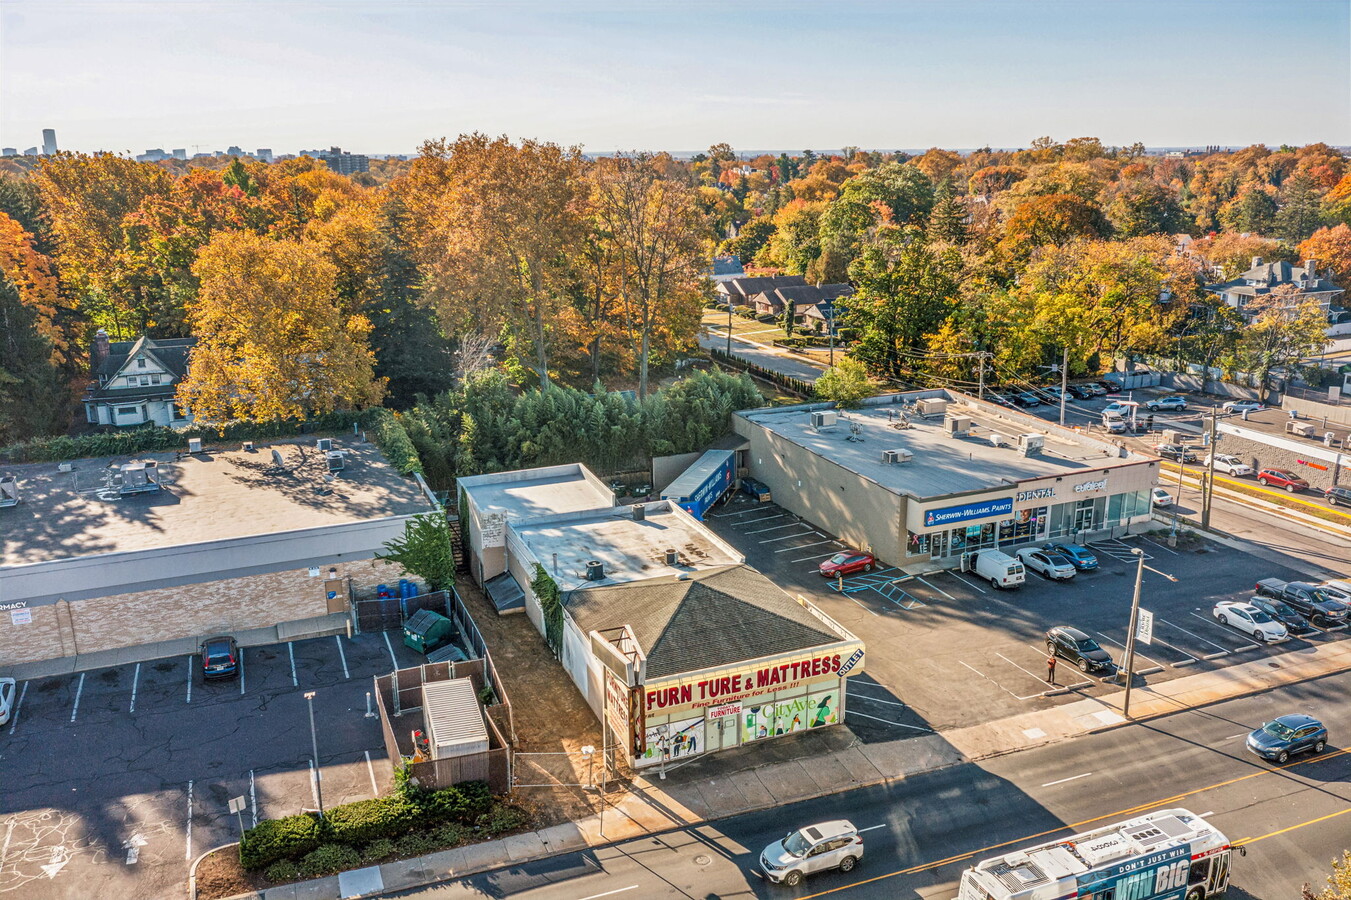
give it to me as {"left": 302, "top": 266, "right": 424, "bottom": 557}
{"left": 84, "top": 328, "right": 197, "bottom": 426}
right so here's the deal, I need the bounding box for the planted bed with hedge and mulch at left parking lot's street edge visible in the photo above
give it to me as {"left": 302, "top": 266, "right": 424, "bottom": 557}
{"left": 196, "top": 777, "right": 532, "bottom": 900}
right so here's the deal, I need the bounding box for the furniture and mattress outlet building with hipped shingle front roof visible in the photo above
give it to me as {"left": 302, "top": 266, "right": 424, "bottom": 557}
{"left": 459, "top": 465, "right": 863, "bottom": 766}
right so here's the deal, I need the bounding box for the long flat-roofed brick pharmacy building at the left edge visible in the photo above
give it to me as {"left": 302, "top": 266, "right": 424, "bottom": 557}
{"left": 0, "top": 441, "right": 431, "bottom": 666}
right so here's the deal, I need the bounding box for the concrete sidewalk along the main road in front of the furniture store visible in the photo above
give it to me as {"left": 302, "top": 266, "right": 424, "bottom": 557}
{"left": 205, "top": 624, "right": 1351, "bottom": 900}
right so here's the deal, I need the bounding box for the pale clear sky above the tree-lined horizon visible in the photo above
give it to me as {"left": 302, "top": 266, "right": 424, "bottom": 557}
{"left": 0, "top": 0, "right": 1351, "bottom": 153}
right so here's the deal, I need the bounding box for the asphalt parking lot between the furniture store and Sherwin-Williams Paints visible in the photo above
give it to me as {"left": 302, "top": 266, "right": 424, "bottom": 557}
{"left": 707, "top": 495, "right": 1344, "bottom": 741}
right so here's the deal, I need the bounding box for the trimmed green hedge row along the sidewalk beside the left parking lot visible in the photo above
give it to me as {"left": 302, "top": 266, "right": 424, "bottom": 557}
{"left": 239, "top": 781, "right": 493, "bottom": 869}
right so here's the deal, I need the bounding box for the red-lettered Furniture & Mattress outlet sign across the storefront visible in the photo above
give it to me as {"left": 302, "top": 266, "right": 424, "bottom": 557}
{"left": 643, "top": 641, "right": 863, "bottom": 716}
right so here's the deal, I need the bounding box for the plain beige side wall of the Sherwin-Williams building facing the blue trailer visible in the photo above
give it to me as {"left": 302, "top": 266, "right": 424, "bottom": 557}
{"left": 732, "top": 416, "right": 905, "bottom": 565}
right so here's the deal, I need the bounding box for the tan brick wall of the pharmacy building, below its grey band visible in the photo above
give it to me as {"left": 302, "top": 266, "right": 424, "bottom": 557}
{"left": 0, "top": 559, "right": 404, "bottom": 666}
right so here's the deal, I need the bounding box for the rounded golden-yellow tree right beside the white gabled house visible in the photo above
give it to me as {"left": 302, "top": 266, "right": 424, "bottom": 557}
{"left": 178, "top": 232, "right": 385, "bottom": 422}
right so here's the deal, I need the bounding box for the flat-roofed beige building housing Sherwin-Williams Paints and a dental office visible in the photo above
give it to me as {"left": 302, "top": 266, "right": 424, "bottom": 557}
{"left": 732, "top": 391, "right": 1159, "bottom": 566}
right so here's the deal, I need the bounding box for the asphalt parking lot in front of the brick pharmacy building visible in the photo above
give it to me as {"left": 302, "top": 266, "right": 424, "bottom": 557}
{"left": 0, "top": 632, "right": 422, "bottom": 900}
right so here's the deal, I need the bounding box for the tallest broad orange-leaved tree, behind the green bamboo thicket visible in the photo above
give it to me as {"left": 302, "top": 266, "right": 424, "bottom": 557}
{"left": 428, "top": 134, "right": 585, "bottom": 385}
